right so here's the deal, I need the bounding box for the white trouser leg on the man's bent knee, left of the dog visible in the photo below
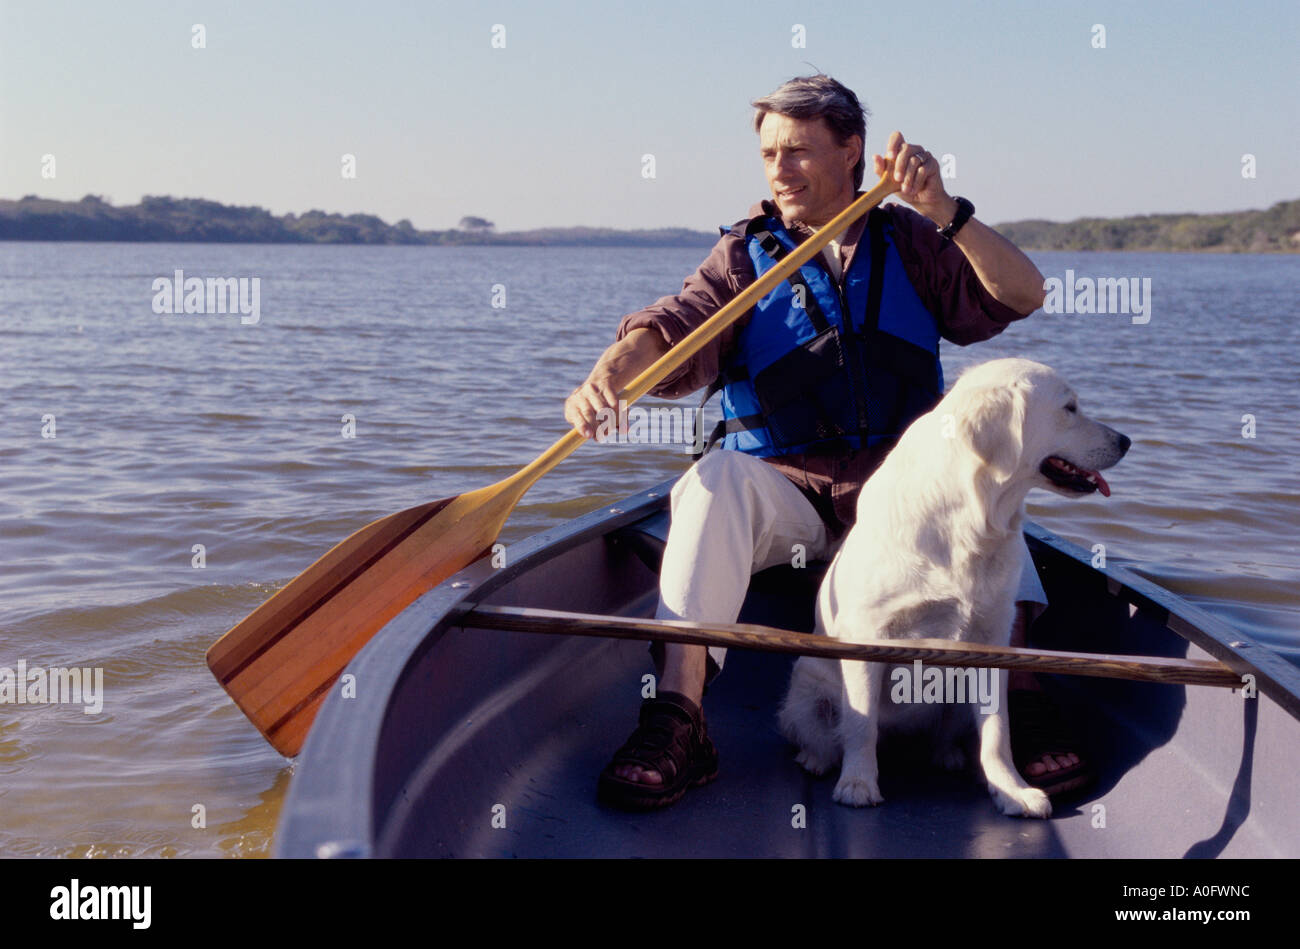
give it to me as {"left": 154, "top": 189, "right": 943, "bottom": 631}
{"left": 655, "top": 449, "right": 829, "bottom": 670}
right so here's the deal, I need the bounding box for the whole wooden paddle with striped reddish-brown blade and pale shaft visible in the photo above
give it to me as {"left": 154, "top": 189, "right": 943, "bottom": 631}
{"left": 208, "top": 166, "right": 898, "bottom": 757}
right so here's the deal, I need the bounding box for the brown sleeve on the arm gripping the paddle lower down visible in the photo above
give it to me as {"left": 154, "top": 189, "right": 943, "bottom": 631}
{"left": 616, "top": 234, "right": 754, "bottom": 399}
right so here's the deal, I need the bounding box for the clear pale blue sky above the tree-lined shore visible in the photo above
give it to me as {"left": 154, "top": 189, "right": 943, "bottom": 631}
{"left": 0, "top": 0, "right": 1300, "bottom": 230}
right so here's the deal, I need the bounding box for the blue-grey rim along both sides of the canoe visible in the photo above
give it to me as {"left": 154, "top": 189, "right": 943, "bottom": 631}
{"left": 273, "top": 477, "right": 1300, "bottom": 858}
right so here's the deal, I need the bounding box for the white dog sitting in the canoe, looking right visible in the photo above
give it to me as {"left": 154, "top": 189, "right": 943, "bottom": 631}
{"left": 779, "top": 359, "right": 1130, "bottom": 818}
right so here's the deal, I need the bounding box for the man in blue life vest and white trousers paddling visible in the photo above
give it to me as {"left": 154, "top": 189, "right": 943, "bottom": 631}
{"left": 564, "top": 75, "right": 1086, "bottom": 809}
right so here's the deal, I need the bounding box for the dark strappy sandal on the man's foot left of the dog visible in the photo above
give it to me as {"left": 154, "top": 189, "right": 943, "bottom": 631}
{"left": 597, "top": 692, "right": 718, "bottom": 810}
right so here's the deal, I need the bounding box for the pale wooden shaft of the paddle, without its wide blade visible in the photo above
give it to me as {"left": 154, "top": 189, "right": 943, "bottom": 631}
{"left": 510, "top": 172, "right": 898, "bottom": 490}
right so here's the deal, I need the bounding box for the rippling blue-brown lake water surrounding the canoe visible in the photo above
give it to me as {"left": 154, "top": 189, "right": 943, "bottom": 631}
{"left": 0, "top": 243, "right": 1300, "bottom": 855}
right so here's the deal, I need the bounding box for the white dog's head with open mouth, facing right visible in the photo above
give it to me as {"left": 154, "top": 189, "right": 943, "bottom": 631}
{"left": 940, "top": 359, "right": 1131, "bottom": 498}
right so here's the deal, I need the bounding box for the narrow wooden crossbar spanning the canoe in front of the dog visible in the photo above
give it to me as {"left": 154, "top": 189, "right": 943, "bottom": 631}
{"left": 460, "top": 606, "right": 1242, "bottom": 689}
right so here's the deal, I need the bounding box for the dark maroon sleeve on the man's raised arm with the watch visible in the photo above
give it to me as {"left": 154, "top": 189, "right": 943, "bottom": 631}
{"left": 887, "top": 204, "right": 1028, "bottom": 346}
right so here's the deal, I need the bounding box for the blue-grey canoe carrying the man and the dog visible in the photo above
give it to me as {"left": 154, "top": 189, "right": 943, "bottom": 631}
{"left": 274, "top": 481, "right": 1300, "bottom": 858}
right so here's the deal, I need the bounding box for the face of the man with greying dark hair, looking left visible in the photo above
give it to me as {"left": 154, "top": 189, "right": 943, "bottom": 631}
{"left": 758, "top": 112, "right": 862, "bottom": 228}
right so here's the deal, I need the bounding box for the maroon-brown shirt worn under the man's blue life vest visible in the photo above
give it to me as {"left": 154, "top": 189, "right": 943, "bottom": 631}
{"left": 618, "top": 202, "right": 1027, "bottom": 536}
